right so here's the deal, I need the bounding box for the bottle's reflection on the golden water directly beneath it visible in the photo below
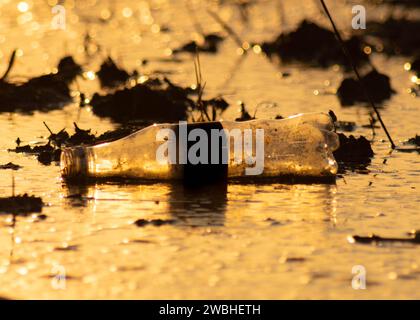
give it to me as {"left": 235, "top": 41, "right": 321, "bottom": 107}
{"left": 62, "top": 183, "right": 337, "bottom": 227}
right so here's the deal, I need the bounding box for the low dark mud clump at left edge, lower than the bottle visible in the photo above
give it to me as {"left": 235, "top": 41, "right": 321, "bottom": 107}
{"left": 0, "top": 193, "right": 44, "bottom": 215}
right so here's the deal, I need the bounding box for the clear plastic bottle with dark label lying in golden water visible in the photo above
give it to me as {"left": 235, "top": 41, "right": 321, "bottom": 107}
{"left": 61, "top": 113, "right": 339, "bottom": 180}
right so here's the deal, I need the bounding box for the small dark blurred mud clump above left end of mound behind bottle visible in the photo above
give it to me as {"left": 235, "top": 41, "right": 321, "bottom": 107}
{"left": 96, "top": 57, "right": 138, "bottom": 88}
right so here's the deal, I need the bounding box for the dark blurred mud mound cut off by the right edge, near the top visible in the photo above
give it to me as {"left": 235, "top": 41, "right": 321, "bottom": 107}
{"left": 364, "top": 17, "right": 420, "bottom": 55}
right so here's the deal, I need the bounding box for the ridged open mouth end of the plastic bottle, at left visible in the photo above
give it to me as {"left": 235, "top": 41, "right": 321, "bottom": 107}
{"left": 60, "top": 147, "right": 88, "bottom": 179}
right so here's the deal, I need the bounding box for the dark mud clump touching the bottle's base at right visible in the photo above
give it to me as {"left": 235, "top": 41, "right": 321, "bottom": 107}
{"left": 333, "top": 133, "right": 374, "bottom": 170}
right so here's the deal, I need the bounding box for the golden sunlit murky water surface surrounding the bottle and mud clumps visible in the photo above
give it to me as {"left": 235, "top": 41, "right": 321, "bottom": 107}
{"left": 0, "top": 0, "right": 420, "bottom": 299}
